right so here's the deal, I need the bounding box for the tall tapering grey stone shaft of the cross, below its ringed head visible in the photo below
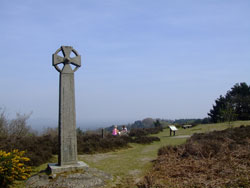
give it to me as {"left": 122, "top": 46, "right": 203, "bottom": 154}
{"left": 59, "top": 68, "right": 77, "bottom": 165}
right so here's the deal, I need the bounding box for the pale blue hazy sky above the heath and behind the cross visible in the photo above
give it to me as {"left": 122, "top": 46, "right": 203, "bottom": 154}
{"left": 0, "top": 0, "right": 250, "bottom": 128}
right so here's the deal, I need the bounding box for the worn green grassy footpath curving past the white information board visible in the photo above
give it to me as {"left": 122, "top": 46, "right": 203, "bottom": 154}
{"left": 79, "top": 121, "right": 250, "bottom": 187}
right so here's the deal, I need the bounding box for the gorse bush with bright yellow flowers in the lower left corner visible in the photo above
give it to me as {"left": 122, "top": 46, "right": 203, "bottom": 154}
{"left": 0, "top": 150, "right": 31, "bottom": 187}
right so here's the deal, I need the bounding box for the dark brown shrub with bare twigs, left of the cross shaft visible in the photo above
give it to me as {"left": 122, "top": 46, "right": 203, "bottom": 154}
{"left": 0, "top": 109, "right": 54, "bottom": 166}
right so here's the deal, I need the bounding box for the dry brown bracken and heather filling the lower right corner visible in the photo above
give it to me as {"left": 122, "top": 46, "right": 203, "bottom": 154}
{"left": 137, "top": 126, "right": 250, "bottom": 188}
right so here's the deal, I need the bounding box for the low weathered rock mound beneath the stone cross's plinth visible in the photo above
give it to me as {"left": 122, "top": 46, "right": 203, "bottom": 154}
{"left": 26, "top": 168, "right": 113, "bottom": 188}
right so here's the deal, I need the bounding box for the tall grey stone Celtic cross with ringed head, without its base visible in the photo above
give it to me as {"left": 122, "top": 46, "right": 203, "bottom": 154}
{"left": 52, "top": 46, "right": 81, "bottom": 166}
